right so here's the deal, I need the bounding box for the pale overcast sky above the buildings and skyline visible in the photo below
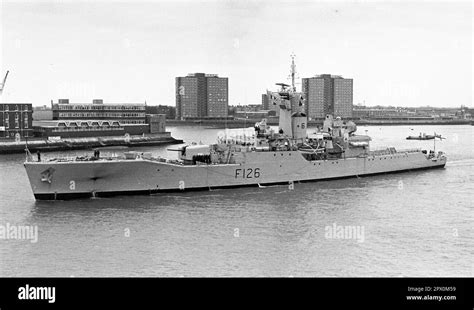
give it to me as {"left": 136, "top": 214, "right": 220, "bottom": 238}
{"left": 0, "top": 0, "right": 474, "bottom": 107}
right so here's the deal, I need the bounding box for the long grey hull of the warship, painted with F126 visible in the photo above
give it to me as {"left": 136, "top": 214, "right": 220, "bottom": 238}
{"left": 25, "top": 151, "right": 446, "bottom": 200}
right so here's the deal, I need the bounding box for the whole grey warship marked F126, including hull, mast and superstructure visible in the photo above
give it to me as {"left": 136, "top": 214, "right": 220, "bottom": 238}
{"left": 24, "top": 61, "right": 447, "bottom": 200}
